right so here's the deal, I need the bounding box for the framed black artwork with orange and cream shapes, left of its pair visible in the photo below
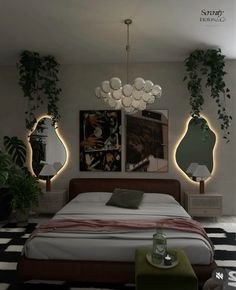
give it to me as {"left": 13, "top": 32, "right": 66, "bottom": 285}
{"left": 80, "top": 110, "right": 121, "bottom": 171}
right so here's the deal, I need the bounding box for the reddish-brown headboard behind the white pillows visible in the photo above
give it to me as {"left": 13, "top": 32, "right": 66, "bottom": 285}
{"left": 69, "top": 178, "right": 181, "bottom": 202}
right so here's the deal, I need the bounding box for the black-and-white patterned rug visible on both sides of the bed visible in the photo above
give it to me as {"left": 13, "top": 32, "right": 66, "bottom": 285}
{"left": 0, "top": 223, "right": 236, "bottom": 290}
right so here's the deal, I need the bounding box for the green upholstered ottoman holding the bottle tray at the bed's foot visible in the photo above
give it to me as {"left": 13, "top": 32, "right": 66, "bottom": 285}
{"left": 135, "top": 248, "right": 198, "bottom": 290}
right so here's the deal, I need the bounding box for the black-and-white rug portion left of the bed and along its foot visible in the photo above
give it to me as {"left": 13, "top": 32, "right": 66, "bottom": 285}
{"left": 0, "top": 223, "right": 134, "bottom": 290}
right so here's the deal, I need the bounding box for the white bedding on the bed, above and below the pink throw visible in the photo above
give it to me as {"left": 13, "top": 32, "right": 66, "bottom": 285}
{"left": 24, "top": 192, "right": 213, "bottom": 265}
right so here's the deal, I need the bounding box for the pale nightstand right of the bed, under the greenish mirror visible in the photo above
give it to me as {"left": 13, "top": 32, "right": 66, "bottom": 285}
{"left": 184, "top": 192, "right": 222, "bottom": 217}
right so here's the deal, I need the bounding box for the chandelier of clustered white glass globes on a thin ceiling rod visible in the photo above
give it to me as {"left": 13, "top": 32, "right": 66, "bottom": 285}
{"left": 95, "top": 19, "right": 162, "bottom": 113}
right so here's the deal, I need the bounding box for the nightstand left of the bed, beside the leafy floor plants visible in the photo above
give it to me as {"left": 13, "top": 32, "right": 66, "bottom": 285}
{"left": 38, "top": 189, "right": 68, "bottom": 214}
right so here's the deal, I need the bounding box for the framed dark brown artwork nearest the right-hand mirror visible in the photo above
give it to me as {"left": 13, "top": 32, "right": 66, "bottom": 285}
{"left": 125, "top": 110, "right": 168, "bottom": 172}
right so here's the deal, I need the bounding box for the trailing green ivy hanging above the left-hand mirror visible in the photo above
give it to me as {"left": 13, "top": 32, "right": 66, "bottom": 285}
{"left": 18, "top": 50, "right": 61, "bottom": 130}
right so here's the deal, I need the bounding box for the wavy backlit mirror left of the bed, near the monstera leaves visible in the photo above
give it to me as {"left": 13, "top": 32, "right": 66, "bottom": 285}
{"left": 29, "top": 117, "right": 67, "bottom": 176}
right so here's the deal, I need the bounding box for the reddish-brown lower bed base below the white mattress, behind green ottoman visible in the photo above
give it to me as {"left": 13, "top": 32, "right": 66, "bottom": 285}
{"left": 18, "top": 256, "right": 217, "bottom": 285}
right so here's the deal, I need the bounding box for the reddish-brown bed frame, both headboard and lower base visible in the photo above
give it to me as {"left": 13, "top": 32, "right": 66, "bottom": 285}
{"left": 18, "top": 178, "right": 216, "bottom": 284}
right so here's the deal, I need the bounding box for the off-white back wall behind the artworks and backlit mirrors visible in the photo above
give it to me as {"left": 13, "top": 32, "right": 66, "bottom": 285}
{"left": 0, "top": 61, "right": 236, "bottom": 214}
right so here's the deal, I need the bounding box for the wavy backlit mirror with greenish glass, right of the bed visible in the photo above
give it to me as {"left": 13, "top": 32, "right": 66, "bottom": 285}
{"left": 176, "top": 118, "right": 216, "bottom": 177}
